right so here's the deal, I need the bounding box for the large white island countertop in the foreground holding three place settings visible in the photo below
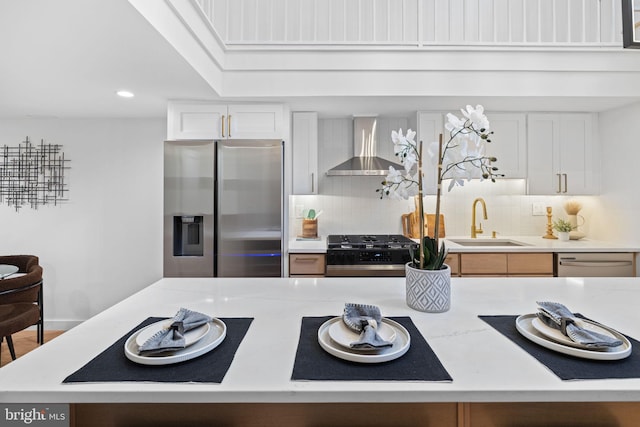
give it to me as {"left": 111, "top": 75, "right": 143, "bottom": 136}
{"left": 0, "top": 278, "right": 640, "bottom": 403}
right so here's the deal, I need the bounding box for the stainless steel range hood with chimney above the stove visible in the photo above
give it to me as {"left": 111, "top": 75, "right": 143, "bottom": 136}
{"left": 327, "top": 116, "right": 404, "bottom": 176}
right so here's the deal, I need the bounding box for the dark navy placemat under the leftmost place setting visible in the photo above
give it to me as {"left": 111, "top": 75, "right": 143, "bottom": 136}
{"left": 63, "top": 317, "right": 253, "bottom": 383}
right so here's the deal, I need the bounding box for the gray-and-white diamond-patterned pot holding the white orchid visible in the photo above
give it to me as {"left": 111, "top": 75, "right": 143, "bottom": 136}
{"left": 405, "top": 263, "right": 451, "bottom": 313}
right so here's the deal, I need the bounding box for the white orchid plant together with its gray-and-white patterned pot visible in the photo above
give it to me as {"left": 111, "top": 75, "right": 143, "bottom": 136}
{"left": 376, "top": 105, "right": 503, "bottom": 312}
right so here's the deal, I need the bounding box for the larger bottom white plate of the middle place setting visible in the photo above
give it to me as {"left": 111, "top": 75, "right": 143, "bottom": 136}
{"left": 318, "top": 317, "right": 411, "bottom": 363}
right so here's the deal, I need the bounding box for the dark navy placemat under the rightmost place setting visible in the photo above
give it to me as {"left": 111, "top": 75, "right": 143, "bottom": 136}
{"left": 478, "top": 315, "right": 640, "bottom": 380}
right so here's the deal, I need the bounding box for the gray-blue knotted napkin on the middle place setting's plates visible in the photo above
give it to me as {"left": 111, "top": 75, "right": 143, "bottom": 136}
{"left": 342, "top": 303, "right": 393, "bottom": 350}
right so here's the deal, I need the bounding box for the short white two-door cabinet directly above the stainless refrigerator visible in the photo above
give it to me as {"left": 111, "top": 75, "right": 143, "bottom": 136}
{"left": 167, "top": 102, "right": 284, "bottom": 140}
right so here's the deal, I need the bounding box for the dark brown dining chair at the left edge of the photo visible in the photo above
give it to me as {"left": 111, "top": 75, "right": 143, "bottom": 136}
{"left": 0, "top": 255, "right": 44, "bottom": 344}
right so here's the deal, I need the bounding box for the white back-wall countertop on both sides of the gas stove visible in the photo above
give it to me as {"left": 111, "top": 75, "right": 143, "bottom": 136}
{"left": 289, "top": 236, "right": 640, "bottom": 253}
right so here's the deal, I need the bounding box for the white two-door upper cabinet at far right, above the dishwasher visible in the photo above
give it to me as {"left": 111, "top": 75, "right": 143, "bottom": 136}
{"left": 527, "top": 113, "right": 600, "bottom": 195}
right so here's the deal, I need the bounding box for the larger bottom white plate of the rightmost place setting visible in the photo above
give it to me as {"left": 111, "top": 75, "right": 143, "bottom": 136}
{"left": 516, "top": 314, "right": 631, "bottom": 360}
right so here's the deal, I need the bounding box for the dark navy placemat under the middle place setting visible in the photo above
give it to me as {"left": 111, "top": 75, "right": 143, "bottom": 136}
{"left": 291, "top": 316, "right": 452, "bottom": 381}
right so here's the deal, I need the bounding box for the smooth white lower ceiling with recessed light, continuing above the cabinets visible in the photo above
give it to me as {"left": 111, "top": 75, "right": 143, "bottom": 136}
{"left": 0, "top": 0, "right": 638, "bottom": 118}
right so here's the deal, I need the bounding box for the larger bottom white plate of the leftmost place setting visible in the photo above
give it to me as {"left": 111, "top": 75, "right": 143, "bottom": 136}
{"left": 124, "top": 318, "right": 227, "bottom": 365}
